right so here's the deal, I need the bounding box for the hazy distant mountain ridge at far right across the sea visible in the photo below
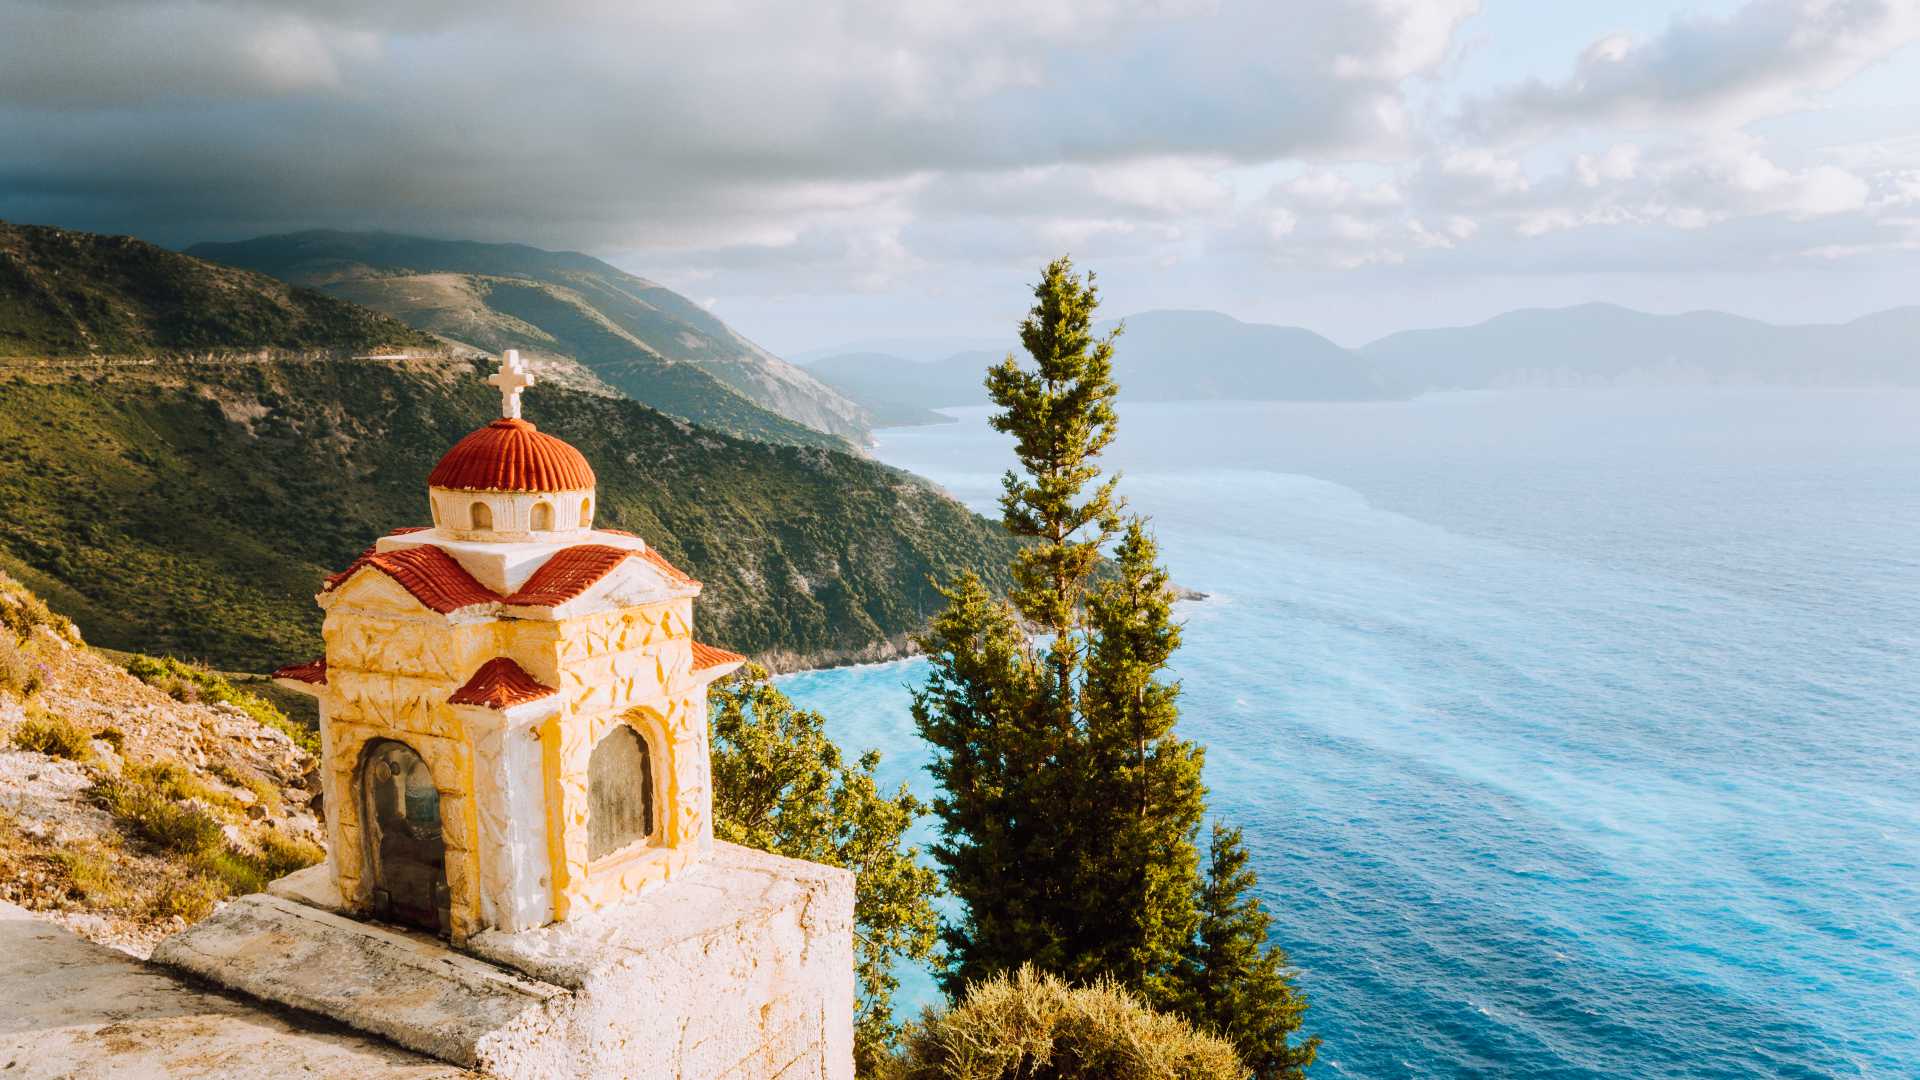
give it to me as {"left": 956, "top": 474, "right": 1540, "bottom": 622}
{"left": 1359, "top": 304, "right": 1920, "bottom": 394}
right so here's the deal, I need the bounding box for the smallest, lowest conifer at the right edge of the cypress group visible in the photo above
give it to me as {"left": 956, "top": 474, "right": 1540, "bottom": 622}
{"left": 1173, "top": 824, "right": 1319, "bottom": 1080}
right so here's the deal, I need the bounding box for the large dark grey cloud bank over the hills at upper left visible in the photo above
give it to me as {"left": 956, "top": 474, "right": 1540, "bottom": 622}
{"left": 0, "top": 0, "right": 1459, "bottom": 246}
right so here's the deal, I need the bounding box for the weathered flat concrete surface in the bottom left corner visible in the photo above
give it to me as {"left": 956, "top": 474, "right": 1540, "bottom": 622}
{"left": 0, "top": 903, "right": 474, "bottom": 1080}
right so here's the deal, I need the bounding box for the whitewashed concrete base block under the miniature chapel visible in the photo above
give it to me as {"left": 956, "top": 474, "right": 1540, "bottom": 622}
{"left": 154, "top": 844, "right": 854, "bottom": 1080}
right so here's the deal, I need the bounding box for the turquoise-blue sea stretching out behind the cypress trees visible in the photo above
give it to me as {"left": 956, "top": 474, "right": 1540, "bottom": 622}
{"left": 783, "top": 390, "right": 1920, "bottom": 1078}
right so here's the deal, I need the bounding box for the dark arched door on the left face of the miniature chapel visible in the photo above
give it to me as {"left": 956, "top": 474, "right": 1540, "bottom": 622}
{"left": 361, "top": 740, "right": 451, "bottom": 934}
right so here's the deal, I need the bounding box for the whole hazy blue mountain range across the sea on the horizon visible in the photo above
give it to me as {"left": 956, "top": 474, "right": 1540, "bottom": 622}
{"left": 812, "top": 304, "right": 1920, "bottom": 423}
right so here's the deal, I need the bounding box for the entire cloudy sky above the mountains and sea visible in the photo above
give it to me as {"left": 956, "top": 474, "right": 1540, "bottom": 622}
{"left": 0, "top": 0, "right": 1920, "bottom": 354}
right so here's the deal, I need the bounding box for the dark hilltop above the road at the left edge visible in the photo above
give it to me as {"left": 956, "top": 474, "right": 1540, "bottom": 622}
{"left": 0, "top": 221, "right": 438, "bottom": 357}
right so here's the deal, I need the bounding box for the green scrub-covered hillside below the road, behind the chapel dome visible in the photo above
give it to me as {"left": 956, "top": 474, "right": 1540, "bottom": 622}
{"left": 0, "top": 357, "right": 1012, "bottom": 671}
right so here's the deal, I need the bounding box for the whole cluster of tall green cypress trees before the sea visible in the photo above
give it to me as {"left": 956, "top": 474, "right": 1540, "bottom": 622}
{"left": 914, "top": 258, "right": 1313, "bottom": 1078}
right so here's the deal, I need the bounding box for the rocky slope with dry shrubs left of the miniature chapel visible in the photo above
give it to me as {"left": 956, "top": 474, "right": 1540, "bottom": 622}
{"left": 0, "top": 575, "right": 323, "bottom": 957}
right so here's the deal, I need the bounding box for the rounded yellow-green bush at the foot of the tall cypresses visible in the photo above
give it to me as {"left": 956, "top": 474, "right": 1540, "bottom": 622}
{"left": 881, "top": 969, "right": 1246, "bottom": 1080}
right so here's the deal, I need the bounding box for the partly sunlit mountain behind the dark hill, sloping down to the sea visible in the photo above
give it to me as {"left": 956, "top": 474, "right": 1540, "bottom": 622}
{"left": 188, "top": 231, "right": 870, "bottom": 444}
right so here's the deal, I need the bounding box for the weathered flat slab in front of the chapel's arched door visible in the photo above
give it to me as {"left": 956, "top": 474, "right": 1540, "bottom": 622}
{"left": 154, "top": 894, "right": 568, "bottom": 1067}
